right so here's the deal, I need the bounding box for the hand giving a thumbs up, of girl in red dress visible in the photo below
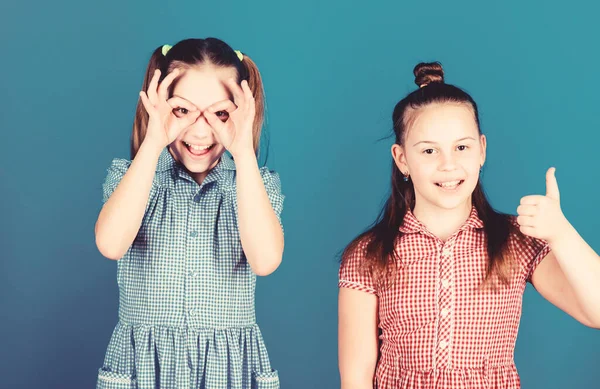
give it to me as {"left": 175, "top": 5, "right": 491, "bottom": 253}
{"left": 517, "top": 168, "right": 569, "bottom": 242}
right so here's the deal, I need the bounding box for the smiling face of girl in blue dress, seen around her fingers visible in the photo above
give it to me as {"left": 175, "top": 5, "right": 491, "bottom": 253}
{"left": 170, "top": 65, "right": 237, "bottom": 183}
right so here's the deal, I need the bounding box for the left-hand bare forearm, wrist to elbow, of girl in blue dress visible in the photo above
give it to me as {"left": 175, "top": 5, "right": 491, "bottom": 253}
{"left": 95, "top": 144, "right": 161, "bottom": 260}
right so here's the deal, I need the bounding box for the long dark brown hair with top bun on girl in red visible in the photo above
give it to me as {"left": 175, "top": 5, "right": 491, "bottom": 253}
{"left": 342, "top": 62, "right": 518, "bottom": 286}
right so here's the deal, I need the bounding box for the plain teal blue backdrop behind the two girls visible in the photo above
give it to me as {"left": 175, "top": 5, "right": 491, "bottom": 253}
{"left": 0, "top": 0, "right": 600, "bottom": 389}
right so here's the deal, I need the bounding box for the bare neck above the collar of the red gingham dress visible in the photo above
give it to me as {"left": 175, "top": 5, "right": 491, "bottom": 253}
{"left": 413, "top": 198, "right": 473, "bottom": 241}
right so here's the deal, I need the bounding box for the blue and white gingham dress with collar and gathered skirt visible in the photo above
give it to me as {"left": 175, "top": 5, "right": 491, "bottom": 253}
{"left": 97, "top": 149, "right": 284, "bottom": 389}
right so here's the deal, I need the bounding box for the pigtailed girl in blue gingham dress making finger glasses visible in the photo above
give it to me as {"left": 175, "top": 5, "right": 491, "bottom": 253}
{"left": 96, "top": 38, "right": 284, "bottom": 389}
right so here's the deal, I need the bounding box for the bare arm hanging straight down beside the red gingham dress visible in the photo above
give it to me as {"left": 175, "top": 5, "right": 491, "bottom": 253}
{"left": 338, "top": 288, "right": 378, "bottom": 389}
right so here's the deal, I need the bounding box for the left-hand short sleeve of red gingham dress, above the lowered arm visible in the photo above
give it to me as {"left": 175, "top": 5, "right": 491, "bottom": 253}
{"left": 338, "top": 242, "right": 377, "bottom": 294}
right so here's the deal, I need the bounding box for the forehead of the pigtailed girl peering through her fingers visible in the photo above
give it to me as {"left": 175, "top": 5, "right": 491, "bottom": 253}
{"left": 173, "top": 65, "right": 237, "bottom": 110}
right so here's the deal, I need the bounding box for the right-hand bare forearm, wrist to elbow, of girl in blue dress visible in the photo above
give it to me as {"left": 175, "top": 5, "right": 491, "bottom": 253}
{"left": 235, "top": 151, "right": 284, "bottom": 276}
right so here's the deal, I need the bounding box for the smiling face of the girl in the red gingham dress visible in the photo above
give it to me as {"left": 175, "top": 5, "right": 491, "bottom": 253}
{"left": 392, "top": 103, "right": 486, "bottom": 210}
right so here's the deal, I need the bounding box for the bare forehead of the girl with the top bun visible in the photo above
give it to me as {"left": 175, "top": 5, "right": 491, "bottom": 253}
{"left": 406, "top": 103, "right": 479, "bottom": 143}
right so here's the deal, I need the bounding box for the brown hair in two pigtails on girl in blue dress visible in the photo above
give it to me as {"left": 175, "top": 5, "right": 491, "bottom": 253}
{"left": 131, "top": 38, "right": 265, "bottom": 159}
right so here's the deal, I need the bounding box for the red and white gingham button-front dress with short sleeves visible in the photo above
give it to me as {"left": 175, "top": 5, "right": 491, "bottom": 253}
{"left": 339, "top": 208, "right": 549, "bottom": 389}
